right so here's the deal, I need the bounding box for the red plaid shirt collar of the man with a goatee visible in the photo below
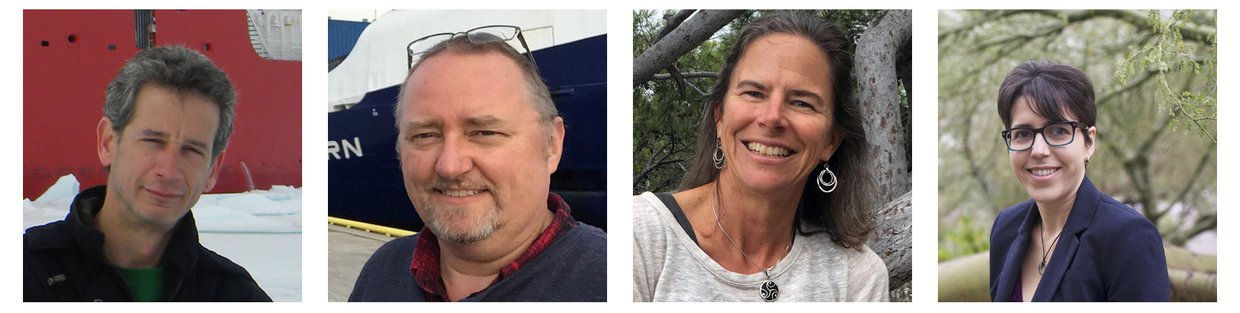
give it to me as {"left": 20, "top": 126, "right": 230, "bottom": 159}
{"left": 409, "top": 194, "right": 577, "bottom": 302}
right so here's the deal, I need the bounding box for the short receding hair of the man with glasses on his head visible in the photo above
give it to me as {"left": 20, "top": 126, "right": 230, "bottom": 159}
{"left": 393, "top": 35, "right": 559, "bottom": 129}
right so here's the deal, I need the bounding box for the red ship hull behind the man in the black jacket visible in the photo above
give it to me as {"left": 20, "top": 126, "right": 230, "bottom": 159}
{"left": 22, "top": 10, "right": 301, "bottom": 199}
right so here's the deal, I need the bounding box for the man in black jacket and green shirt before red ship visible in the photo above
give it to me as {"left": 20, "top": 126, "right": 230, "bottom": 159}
{"left": 24, "top": 46, "right": 270, "bottom": 302}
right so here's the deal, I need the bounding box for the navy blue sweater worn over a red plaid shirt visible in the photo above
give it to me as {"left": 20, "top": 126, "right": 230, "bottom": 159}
{"left": 348, "top": 224, "right": 608, "bottom": 302}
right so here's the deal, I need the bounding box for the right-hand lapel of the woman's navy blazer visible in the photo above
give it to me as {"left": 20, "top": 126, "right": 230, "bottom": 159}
{"left": 1033, "top": 176, "right": 1099, "bottom": 301}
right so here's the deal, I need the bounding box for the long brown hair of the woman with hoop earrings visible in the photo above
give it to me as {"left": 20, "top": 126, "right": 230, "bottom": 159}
{"left": 680, "top": 12, "right": 877, "bottom": 248}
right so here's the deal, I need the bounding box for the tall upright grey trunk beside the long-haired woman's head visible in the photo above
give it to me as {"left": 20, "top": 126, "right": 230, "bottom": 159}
{"left": 853, "top": 10, "right": 913, "bottom": 202}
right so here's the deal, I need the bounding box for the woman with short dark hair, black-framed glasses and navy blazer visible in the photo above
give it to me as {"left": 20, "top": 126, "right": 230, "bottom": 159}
{"left": 990, "top": 62, "right": 1171, "bottom": 302}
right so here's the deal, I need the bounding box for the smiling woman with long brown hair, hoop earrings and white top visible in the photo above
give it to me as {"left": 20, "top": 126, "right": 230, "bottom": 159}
{"left": 634, "top": 14, "right": 888, "bottom": 302}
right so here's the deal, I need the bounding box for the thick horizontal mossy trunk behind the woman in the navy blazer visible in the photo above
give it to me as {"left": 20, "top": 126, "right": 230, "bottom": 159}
{"left": 939, "top": 242, "right": 1218, "bottom": 302}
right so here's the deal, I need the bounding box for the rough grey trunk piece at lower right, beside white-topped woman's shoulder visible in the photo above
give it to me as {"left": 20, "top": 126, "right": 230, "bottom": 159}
{"left": 866, "top": 191, "right": 913, "bottom": 298}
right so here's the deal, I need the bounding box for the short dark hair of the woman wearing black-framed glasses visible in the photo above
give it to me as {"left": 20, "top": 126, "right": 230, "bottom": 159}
{"left": 998, "top": 61, "right": 1097, "bottom": 143}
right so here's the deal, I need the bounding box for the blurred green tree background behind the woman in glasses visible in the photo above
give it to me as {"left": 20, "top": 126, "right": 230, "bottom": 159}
{"left": 939, "top": 10, "right": 1218, "bottom": 301}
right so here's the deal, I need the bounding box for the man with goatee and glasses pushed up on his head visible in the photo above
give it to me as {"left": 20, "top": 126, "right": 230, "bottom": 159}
{"left": 350, "top": 31, "right": 606, "bottom": 302}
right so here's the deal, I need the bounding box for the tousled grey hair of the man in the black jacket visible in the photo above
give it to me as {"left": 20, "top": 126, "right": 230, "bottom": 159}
{"left": 103, "top": 46, "right": 237, "bottom": 158}
